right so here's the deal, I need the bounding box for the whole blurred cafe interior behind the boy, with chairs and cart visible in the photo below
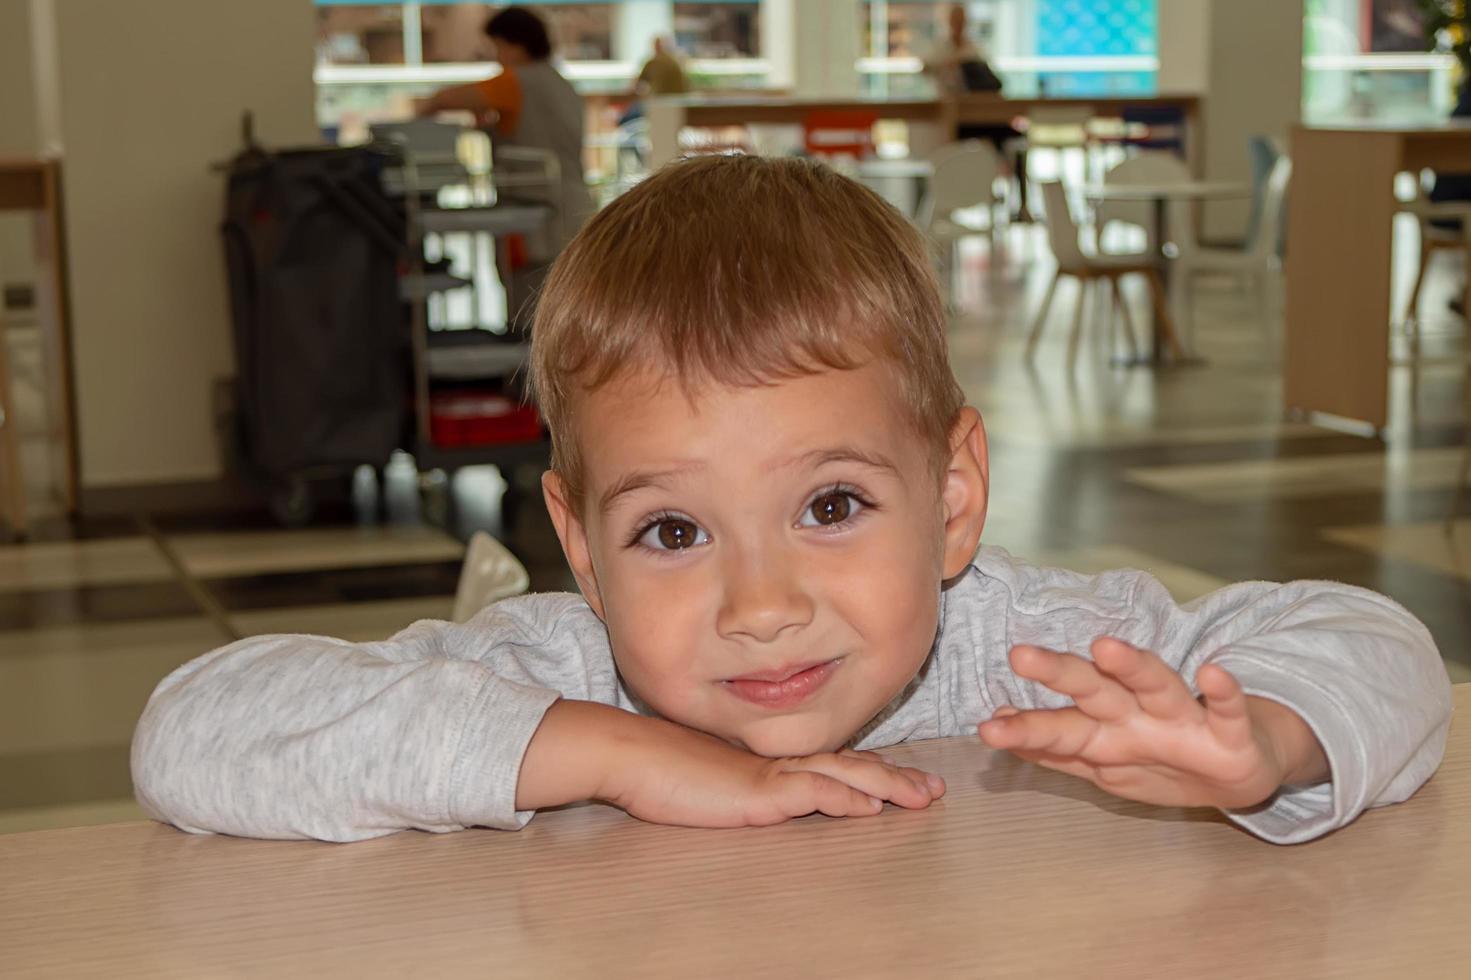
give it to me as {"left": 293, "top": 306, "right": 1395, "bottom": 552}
{"left": 0, "top": 0, "right": 1471, "bottom": 833}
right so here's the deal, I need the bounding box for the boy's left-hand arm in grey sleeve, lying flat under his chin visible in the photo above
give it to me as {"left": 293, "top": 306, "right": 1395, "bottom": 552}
{"left": 132, "top": 597, "right": 944, "bottom": 840}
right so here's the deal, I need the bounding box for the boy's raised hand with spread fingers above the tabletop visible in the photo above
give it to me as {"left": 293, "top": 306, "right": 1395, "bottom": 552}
{"left": 980, "top": 639, "right": 1328, "bottom": 809}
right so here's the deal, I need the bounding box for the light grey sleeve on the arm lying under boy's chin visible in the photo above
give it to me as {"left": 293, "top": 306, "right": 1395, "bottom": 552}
{"left": 132, "top": 597, "right": 616, "bottom": 840}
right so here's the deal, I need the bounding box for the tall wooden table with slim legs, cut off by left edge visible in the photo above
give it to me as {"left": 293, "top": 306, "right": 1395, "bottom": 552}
{"left": 0, "top": 156, "right": 78, "bottom": 534}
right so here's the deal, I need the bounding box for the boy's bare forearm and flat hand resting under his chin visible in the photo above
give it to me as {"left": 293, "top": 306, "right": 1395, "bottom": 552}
{"left": 516, "top": 702, "right": 944, "bottom": 827}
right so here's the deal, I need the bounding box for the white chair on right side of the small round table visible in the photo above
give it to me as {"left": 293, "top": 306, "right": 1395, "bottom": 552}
{"left": 1169, "top": 156, "right": 1292, "bottom": 346}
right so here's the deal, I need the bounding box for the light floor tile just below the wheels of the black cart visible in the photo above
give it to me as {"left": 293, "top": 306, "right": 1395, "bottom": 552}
{"left": 169, "top": 527, "right": 465, "bottom": 578}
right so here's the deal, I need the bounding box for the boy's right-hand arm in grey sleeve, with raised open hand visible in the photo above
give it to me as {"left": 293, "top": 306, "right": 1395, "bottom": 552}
{"left": 959, "top": 561, "right": 1450, "bottom": 843}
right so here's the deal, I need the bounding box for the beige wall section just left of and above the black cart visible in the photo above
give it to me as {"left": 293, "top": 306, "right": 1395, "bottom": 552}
{"left": 39, "top": 0, "right": 318, "bottom": 487}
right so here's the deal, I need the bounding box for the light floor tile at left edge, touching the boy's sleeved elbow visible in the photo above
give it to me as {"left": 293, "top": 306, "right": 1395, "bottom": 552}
{"left": 0, "top": 618, "right": 227, "bottom": 756}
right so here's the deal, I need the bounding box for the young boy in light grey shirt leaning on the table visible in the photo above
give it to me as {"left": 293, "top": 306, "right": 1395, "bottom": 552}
{"left": 132, "top": 157, "right": 1450, "bottom": 843}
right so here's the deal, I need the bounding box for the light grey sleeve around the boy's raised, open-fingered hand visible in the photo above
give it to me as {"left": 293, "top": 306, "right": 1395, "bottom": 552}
{"left": 959, "top": 556, "right": 1452, "bottom": 843}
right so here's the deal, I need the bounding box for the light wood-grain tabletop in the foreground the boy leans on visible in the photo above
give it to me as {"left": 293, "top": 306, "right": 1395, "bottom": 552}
{"left": 0, "top": 686, "right": 1471, "bottom": 980}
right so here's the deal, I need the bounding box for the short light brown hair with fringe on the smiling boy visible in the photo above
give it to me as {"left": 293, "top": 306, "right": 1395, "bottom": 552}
{"left": 531, "top": 156, "right": 964, "bottom": 508}
